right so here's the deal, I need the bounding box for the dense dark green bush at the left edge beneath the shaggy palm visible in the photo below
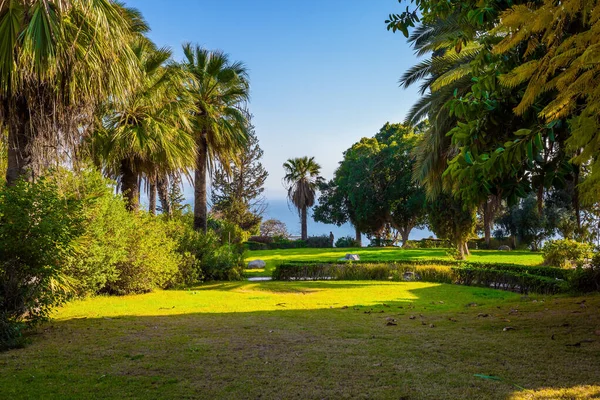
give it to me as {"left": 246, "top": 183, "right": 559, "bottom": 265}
{"left": 0, "top": 178, "right": 84, "bottom": 348}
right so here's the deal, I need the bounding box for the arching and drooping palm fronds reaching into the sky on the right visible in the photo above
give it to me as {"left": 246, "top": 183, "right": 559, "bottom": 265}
{"left": 400, "top": 16, "right": 482, "bottom": 198}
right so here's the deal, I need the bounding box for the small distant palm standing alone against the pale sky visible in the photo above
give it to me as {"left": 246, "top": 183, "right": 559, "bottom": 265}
{"left": 283, "top": 157, "right": 323, "bottom": 240}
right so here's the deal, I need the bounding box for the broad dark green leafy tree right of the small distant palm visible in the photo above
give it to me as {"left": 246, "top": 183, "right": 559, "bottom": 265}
{"left": 314, "top": 123, "right": 425, "bottom": 245}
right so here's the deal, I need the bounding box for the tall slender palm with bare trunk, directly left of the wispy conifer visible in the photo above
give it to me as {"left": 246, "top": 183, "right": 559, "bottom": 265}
{"left": 183, "top": 43, "right": 250, "bottom": 232}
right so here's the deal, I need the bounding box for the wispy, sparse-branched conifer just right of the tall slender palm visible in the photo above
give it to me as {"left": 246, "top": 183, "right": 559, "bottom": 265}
{"left": 211, "top": 120, "right": 269, "bottom": 231}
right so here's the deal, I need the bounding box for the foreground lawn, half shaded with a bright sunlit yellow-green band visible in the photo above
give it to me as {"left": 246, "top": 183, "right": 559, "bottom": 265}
{"left": 0, "top": 281, "right": 600, "bottom": 399}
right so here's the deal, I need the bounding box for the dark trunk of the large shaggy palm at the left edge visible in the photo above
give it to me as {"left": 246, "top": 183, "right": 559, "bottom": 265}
{"left": 6, "top": 100, "right": 33, "bottom": 185}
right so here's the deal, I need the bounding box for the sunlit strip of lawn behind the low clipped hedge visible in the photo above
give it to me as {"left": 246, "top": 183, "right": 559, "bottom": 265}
{"left": 246, "top": 247, "right": 542, "bottom": 276}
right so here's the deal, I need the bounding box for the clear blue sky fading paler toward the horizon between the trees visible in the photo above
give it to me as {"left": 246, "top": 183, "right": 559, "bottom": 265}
{"left": 126, "top": 0, "right": 426, "bottom": 238}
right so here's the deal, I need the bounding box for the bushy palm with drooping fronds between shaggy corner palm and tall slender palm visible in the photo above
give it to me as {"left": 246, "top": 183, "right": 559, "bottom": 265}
{"left": 91, "top": 38, "right": 196, "bottom": 211}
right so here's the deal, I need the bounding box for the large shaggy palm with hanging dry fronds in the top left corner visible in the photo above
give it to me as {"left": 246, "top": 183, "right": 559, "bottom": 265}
{"left": 0, "top": 0, "right": 147, "bottom": 184}
